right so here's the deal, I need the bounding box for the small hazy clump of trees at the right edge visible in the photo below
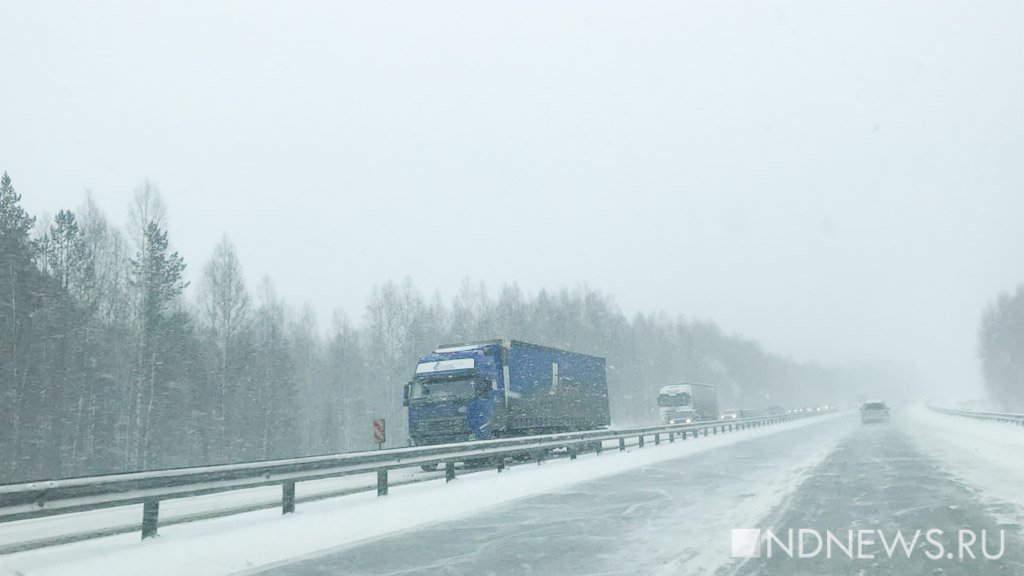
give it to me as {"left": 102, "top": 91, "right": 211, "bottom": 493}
{"left": 978, "top": 285, "right": 1024, "bottom": 411}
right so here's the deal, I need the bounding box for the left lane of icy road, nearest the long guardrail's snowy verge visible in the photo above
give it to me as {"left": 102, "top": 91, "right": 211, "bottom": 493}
{"left": 250, "top": 416, "right": 860, "bottom": 576}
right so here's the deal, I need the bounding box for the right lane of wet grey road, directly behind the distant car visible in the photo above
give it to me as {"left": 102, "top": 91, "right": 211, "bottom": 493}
{"left": 736, "top": 421, "right": 1024, "bottom": 576}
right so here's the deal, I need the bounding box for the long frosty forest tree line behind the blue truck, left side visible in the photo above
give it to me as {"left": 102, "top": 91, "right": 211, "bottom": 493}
{"left": 0, "top": 173, "right": 844, "bottom": 483}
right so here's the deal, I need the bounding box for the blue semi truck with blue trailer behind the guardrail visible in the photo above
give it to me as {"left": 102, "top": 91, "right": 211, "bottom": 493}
{"left": 403, "top": 340, "right": 609, "bottom": 453}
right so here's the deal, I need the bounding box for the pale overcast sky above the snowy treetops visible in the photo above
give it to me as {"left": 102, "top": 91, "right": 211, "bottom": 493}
{"left": 0, "top": 0, "right": 1024, "bottom": 385}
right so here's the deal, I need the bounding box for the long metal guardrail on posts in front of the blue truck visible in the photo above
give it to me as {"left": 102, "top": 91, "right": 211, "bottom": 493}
{"left": 0, "top": 414, "right": 813, "bottom": 539}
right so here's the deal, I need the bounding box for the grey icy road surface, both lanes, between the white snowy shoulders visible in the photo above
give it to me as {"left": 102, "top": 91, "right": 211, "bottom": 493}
{"left": 245, "top": 416, "right": 1024, "bottom": 576}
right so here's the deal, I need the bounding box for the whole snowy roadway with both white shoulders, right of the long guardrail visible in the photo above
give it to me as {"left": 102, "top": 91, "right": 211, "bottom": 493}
{"left": 8, "top": 408, "right": 1024, "bottom": 576}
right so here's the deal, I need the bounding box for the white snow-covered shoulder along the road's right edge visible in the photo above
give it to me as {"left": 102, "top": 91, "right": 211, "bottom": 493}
{"left": 894, "top": 405, "right": 1024, "bottom": 526}
